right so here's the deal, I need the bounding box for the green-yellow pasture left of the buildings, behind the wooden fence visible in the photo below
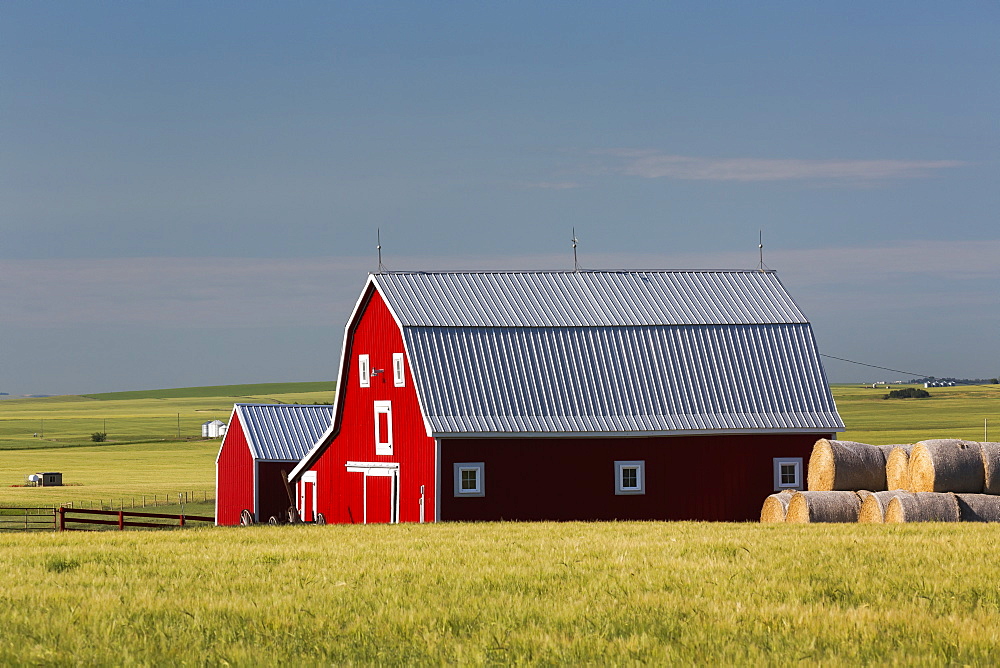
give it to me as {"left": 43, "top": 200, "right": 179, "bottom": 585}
{"left": 0, "top": 383, "right": 333, "bottom": 507}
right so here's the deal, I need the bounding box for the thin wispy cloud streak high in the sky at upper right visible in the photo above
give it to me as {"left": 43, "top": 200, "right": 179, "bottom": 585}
{"left": 602, "top": 149, "right": 966, "bottom": 181}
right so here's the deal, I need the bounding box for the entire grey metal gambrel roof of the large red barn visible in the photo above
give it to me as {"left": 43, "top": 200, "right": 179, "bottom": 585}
{"left": 371, "top": 270, "right": 844, "bottom": 436}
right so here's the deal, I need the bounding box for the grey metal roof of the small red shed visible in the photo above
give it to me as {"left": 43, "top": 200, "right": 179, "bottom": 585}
{"left": 235, "top": 404, "right": 333, "bottom": 462}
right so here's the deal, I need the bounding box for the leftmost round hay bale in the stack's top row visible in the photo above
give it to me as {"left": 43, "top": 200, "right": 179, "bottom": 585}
{"left": 807, "top": 438, "right": 886, "bottom": 492}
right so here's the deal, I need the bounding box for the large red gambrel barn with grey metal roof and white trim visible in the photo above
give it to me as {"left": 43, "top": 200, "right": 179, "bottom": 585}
{"left": 289, "top": 271, "right": 844, "bottom": 523}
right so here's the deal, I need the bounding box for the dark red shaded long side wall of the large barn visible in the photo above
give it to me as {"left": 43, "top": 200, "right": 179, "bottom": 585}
{"left": 441, "top": 434, "right": 820, "bottom": 521}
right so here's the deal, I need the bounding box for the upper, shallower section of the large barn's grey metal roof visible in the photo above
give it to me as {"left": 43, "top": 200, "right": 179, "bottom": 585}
{"left": 374, "top": 271, "right": 806, "bottom": 327}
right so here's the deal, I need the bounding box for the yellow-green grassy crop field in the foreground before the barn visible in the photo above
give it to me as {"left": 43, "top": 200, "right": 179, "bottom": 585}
{"left": 0, "top": 523, "right": 1000, "bottom": 665}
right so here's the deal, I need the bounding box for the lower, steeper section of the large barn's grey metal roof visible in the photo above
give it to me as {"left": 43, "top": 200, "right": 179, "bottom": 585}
{"left": 403, "top": 323, "right": 844, "bottom": 434}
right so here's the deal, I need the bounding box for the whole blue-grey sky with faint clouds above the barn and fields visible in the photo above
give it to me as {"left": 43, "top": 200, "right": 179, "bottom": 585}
{"left": 0, "top": 1, "right": 1000, "bottom": 394}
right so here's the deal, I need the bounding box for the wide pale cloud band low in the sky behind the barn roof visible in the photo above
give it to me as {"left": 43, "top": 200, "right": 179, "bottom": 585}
{"left": 0, "top": 240, "right": 1000, "bottom": 336}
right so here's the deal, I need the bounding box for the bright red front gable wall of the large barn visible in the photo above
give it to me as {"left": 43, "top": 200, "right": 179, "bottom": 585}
{"left": 312, "top": 290, "right": 435, "bottom": 523}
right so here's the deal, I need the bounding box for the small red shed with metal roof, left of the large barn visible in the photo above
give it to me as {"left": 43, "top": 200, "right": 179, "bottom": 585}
{"left": 215, "top": 404, "right": 333, "bottom": 525}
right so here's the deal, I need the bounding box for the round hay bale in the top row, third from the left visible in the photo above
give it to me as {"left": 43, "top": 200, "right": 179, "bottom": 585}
{"left": 909, "top": 439, "right": 986, "bottom": 494}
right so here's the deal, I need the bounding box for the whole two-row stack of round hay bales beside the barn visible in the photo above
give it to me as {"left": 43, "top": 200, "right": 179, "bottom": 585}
{"left": 760, "top": 438, "right": 1000, "bottom": 523}
